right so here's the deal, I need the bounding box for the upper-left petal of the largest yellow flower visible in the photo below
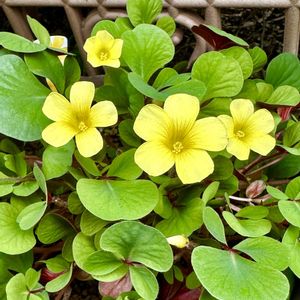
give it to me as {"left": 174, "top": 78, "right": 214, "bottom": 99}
{"left": 133, "top": 104, "right": 172, "bottom": 141}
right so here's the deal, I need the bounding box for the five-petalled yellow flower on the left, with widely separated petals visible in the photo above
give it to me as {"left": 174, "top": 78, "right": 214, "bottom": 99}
{"left": 42, "top": 81, "right": 118, "bottom": 157}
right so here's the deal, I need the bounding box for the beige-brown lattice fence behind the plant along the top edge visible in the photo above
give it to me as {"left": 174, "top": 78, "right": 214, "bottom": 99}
{"left": 0, "top": 0, "right": 300, "bottom": 75}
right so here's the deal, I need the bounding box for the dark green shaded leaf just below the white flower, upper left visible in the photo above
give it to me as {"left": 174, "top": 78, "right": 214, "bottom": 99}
{"left": 24, "top": 51, "right": 65, "bottom": 93}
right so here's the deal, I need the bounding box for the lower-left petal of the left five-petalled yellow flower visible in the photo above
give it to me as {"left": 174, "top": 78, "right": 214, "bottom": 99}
{"left": 42, "top": 122, "right": 77, "bottom": 147}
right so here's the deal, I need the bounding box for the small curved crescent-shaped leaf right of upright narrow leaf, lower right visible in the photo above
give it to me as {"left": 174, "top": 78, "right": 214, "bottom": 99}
{"left": 223, "top": 211, "right": 272, "bottom": 237}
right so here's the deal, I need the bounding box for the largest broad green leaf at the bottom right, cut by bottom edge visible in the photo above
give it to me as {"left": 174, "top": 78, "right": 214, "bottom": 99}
{"left": 192, "top": 246, "right": 289, "bottom": 300}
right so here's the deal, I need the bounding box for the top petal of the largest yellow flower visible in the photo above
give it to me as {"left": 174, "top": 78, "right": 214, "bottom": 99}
{"left": 164, "top": 94, "right": 200, "bottom": 139}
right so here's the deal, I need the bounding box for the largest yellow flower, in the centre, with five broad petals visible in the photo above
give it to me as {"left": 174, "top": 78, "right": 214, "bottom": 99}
{"left": 133, "top": 94, "right": 227, "bottom": 183}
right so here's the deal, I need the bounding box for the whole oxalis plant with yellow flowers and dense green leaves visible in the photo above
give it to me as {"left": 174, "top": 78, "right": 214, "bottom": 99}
{"left": 0, "top": 0, "right": 300, "bottom": 300}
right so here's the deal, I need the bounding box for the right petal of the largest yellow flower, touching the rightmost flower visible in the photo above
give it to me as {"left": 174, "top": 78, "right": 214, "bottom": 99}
{"left": 183, "top": 117, "right": 228, "bottom": 151}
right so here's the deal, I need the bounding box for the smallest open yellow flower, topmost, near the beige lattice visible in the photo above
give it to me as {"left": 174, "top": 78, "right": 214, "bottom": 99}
{"left": 83, "top": 30, "right": 123, "bottom": 68}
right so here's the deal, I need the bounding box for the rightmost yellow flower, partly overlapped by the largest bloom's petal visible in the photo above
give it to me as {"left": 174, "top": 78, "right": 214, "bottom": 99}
{"left": 218, "top": 99, "right": 275, "bottom": 160}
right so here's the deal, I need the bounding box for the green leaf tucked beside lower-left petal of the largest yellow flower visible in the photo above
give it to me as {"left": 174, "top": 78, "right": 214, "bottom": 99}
{"left": 107, "top": 149, "right": 143, "bottom": 180}
